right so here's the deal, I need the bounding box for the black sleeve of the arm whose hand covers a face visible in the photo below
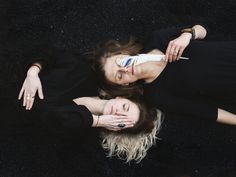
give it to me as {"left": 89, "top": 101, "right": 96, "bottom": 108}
{"left": 39, "top": 101, "right": 93, "bottom": 135}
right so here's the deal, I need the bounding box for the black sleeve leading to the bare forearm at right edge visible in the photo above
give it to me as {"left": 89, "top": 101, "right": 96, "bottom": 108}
{"left": 153, "top": 95, "right": 218, "bottom": 122}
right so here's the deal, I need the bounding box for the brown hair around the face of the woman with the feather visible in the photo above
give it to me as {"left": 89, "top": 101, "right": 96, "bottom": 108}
{"left": 88, "top": 36, "right": 143, "bottom": 98}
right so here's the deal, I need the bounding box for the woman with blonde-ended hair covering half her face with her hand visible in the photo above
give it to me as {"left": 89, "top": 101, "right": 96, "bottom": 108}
{"left": 12, "top": 46, "right": 162, "bottom": 162}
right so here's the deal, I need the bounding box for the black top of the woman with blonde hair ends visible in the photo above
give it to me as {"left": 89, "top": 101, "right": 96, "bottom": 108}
{"left": 30, "top": 51, "right": 98, "bottom": 132}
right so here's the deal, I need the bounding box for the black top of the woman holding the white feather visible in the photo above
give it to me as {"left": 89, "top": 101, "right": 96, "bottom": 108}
{"left": 144, "top": 27, "right": 236, "bottom": 121}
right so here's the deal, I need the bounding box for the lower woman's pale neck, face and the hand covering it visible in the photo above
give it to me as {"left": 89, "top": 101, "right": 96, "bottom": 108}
{"left": 73, "top": 97, "right": 140, "bottom": 131}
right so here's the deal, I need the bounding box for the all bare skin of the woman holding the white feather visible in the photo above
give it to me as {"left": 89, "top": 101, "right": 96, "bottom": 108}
{"left": 104, "top": 25, "right": 236, "bottom": 125}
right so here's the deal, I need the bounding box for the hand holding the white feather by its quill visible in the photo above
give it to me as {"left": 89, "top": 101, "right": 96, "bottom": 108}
{"left": 165, "top": 33, "right": 192, "bottom": 63}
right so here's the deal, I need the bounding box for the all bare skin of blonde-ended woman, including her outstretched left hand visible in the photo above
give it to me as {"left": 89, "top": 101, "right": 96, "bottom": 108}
{"left": 18, "top": 62, "right": 139, "bottom": 131}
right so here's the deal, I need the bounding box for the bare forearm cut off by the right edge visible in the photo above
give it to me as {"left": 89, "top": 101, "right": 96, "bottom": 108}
{"left": 216, "top": 108, "right": 236, "bottom": 125}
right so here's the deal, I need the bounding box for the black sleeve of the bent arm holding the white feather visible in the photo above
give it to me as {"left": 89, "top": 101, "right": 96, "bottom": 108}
{"left": 144, "top": 23, "right": 209, "bottom": 53}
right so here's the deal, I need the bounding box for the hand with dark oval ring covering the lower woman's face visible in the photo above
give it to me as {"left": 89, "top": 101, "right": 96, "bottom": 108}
{"left": 97, "top": 114, "right": 135, "bottom": 131}
